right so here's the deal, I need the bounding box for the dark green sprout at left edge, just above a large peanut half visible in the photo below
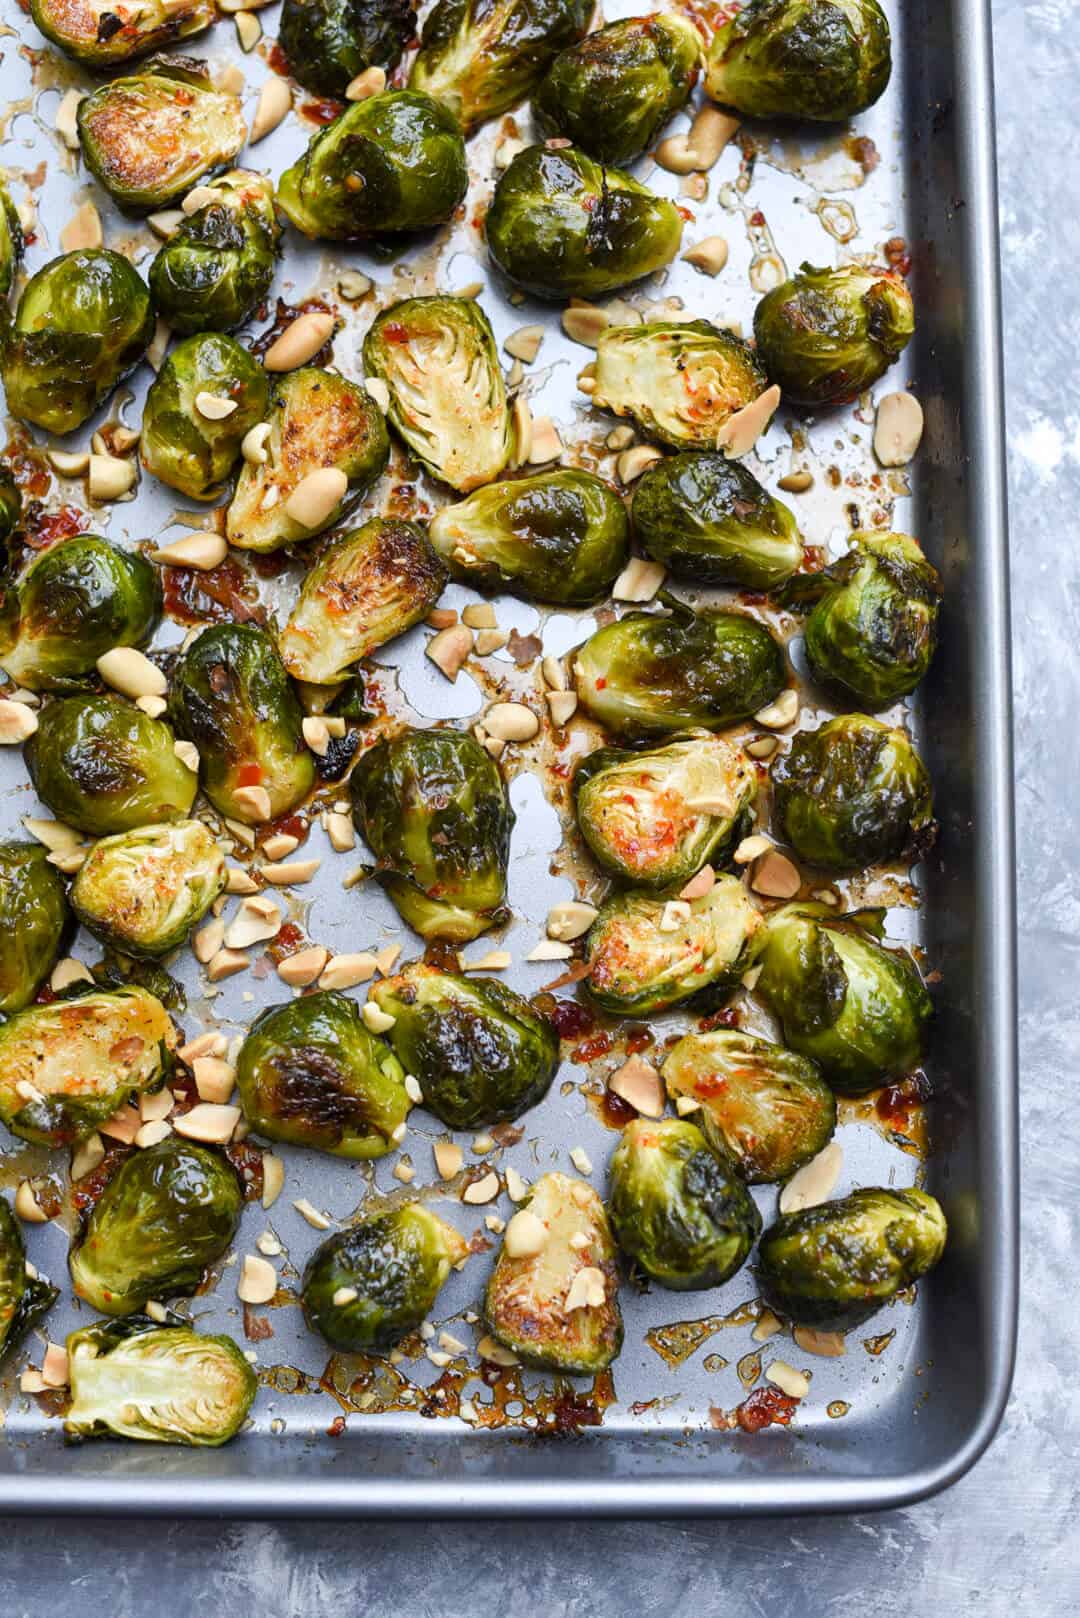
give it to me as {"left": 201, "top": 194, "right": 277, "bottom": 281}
{"left": 0, "top": 534, "right": 162, "bottom": 691}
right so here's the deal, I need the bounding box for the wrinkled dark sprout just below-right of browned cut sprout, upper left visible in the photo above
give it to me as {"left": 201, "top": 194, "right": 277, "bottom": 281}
{"left": 149, "top": 168, "right": 282, "bottom": 337}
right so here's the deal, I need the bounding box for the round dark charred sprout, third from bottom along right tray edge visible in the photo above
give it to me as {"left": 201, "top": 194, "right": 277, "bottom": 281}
{"left": 772, "top": 714, "right": 933, "bottom": 870}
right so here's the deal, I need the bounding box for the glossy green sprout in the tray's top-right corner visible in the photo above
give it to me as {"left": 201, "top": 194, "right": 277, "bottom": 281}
{"left": 704, "top": 0, "right": 892, "bottom": 123}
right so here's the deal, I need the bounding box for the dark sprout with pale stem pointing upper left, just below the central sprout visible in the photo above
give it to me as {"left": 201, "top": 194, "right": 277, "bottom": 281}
{"left": 371, "top": 963, "right": 559, "bottom": 1129}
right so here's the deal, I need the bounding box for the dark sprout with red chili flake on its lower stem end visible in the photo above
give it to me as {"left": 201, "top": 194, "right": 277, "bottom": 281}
{"left": 168, "top": 623, "right": 316, "bottom": 825}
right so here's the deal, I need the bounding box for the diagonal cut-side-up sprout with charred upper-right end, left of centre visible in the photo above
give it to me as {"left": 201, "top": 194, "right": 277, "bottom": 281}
{"left": 279, "top": 516, "right": 447, "bottom": 686}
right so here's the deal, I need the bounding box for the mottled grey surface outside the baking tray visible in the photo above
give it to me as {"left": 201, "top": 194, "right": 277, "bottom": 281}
{"left": 0, "top": 0, "right": 1080, "bottom": 1618}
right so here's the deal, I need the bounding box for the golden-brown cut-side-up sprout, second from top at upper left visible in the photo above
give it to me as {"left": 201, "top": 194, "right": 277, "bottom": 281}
{"left": 78, "top": 57, "right": 248, "bottom": 214}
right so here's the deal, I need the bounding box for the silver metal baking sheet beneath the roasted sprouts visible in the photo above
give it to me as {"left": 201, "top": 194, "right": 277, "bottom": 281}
{"left": 0, "top": 0, "right": 1017, "bottom": 1516}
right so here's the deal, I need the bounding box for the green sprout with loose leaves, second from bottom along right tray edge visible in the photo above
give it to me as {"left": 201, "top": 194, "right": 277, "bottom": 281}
{"left": 756, "top": 904, "right": 933, "bottom": 1095}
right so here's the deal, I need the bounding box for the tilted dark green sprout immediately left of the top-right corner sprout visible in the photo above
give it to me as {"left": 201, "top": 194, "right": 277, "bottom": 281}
{"left": 533, "top": 13, "right": 703, "bottom": 163}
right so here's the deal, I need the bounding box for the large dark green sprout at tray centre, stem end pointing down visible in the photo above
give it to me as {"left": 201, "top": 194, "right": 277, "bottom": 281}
{"left": 350, "top": 730, "right": 513, "bottom": 943}
